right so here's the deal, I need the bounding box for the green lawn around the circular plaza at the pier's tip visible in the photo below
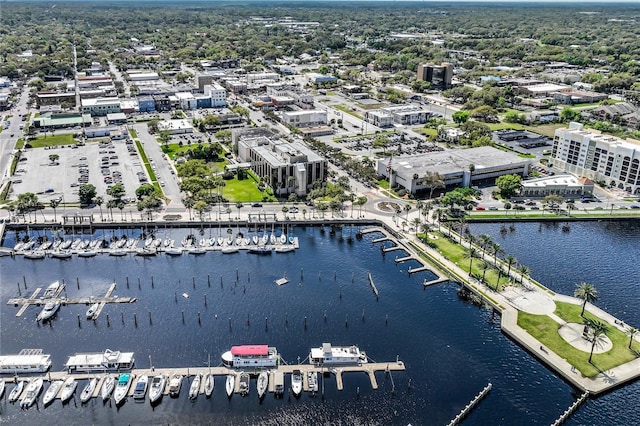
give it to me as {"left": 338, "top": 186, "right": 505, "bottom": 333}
{"left": 518, "top": 302, "right": 640, "bottom": 377}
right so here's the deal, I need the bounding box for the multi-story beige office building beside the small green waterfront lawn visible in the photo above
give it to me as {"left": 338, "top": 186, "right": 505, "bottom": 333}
{"left": 232, "top": 128, "right": 327, "bottom": 196}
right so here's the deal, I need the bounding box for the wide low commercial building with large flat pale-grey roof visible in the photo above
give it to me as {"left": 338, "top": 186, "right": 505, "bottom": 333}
{"left": 377, "top": 146, "right": 531, "bottom": 194}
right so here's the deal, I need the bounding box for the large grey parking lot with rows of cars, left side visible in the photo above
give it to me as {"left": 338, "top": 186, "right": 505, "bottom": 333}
{"left": 11, "top": 139, "right": 148, "bottom": 204}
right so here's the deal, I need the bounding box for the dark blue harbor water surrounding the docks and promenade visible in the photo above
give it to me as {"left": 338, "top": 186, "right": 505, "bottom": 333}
{"left": 0, "top": 224, "right": 640, "bottom": 425}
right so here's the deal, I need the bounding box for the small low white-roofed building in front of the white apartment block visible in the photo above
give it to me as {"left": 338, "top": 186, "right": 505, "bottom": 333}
{"left": 520, "top": 175, "right": 594, "bottom": 198}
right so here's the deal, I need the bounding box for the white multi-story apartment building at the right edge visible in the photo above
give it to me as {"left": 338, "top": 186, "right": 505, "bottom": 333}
{"left": 551, "top": 123, "right": 640, "bottom": 194}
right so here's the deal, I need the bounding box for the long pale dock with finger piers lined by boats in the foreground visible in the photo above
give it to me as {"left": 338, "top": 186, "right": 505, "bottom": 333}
{"left": 4, "top": 361, "right": 405, "bottom": 399}
